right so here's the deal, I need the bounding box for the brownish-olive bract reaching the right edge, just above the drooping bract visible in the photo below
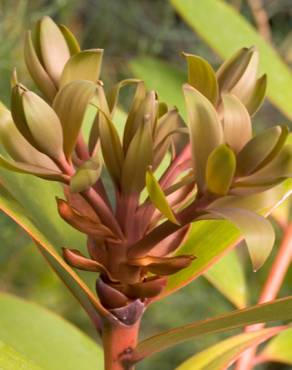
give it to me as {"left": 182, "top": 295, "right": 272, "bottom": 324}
{"left": 238, "top": 144, "right": 292, "bottom": 186}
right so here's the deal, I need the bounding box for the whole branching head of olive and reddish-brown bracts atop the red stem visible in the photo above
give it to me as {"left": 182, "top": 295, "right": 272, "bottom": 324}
{"left": 0, "top": 17, "right": 292, "bottom": 318}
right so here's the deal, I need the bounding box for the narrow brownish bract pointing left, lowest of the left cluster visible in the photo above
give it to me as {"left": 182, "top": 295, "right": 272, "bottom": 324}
{"left": 0, "top": 155, "right": 69, "bottom": 184}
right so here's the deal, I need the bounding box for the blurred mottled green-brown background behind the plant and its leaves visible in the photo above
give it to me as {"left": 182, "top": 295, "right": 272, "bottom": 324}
{"left": 0, "top": 0, "right": 292, "bottom": 370}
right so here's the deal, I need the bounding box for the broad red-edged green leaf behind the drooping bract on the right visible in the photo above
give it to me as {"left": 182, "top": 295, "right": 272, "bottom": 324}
{"left": 160, "top": 180, "right": 292, "bottom": 297}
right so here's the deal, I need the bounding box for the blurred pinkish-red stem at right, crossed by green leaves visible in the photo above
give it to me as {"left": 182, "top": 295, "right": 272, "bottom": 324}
{"left": 236, "top": 223, "right": 292, "bottom": 370}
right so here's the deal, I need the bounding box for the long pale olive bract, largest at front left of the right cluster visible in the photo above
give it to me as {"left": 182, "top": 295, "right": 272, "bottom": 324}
{"left": 183, "top": 85, "right": 223, "bottom": 190}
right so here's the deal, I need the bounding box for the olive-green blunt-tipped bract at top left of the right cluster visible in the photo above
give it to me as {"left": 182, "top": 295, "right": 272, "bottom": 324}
{"left": 183, "top": 53, "right": 218, "bottom": 105}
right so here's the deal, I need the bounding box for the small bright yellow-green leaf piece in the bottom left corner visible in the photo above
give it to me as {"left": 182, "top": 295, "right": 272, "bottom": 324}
{"left": 0, "top": 341, "right": 43, "bottom": 370}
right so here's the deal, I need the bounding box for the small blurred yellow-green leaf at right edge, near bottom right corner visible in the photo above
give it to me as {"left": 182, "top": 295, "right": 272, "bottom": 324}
{"left": 259, "top": 329, "right": 292, "bottom": 366}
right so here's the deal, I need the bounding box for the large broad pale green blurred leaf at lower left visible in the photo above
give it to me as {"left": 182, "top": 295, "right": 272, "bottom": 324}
{"left": 0, "top": 293, "right": 103, "bottom": 370}
